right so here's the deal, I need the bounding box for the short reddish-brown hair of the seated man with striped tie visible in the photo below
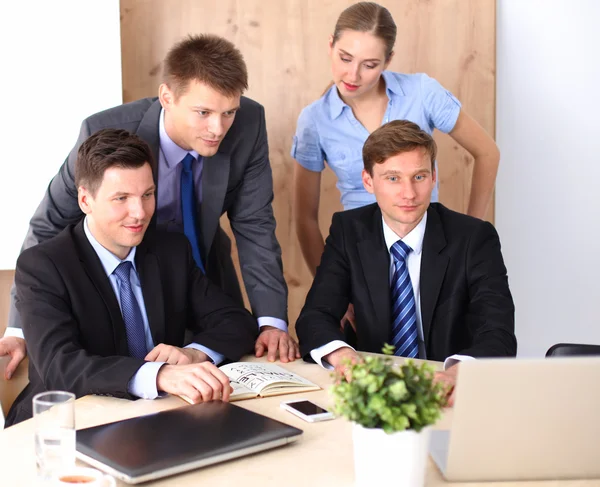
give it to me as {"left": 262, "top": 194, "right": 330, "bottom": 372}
{"left": 363, "top": 120, "right": 437, "bottom": 176}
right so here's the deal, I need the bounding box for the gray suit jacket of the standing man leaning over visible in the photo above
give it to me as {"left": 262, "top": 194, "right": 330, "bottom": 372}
{"left": 8, "top": 97, "right": 287, "bottom": 328}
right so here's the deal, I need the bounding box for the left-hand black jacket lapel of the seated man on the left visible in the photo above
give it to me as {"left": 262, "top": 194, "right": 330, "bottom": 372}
{"left": 73, "top": 220, "right": 129, "bottom": 356}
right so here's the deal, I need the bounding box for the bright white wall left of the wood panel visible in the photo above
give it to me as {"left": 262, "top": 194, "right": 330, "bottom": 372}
{"left": 0, "top": 0, "right": 122, "bottom": 269}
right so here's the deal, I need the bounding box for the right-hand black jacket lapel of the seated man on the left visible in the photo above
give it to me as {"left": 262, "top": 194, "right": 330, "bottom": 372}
{"left": 135, "top": 241, "right": 165, "bottom": 346}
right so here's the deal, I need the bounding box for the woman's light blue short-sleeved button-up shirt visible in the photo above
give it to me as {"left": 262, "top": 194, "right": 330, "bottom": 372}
{"left": 291, "top": 71, "right": 461, "bottom": 210}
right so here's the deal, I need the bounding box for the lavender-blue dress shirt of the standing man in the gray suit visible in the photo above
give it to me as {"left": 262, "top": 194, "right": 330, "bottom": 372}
{"left": 156, "top": 109, "right": 287, "bottom": 331}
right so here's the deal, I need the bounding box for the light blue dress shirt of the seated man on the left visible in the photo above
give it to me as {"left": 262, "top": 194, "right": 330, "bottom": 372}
{"left": 83, "top": 217, "right": 225, "bottom": 399}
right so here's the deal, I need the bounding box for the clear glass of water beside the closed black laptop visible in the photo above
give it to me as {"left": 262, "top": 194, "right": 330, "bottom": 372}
{"left": 33, "top": 391, "right": 75, "bottom": 480}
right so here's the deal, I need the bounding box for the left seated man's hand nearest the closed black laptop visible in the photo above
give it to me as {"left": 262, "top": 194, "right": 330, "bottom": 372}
{"left": 156, "top": 362, "right": 231, "bottom": 404}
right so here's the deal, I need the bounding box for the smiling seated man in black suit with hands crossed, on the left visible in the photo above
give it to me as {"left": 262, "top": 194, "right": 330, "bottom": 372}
{"left": 6, "top": 129, "right": 258, "bottom": 425}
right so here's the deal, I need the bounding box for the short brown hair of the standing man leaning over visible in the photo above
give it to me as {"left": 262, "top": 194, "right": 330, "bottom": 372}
{"left": 163, "top": 34, "right": 248, "bottom": 98}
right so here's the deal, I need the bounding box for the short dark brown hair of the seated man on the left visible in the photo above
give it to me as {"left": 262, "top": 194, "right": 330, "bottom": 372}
{"left": 75, "top": 129, "right": 154, "bottom": 196}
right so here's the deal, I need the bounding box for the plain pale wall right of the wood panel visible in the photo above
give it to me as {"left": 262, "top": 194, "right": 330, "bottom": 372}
{"left": 496, "top": 0, "right": 600, "bottom": 356}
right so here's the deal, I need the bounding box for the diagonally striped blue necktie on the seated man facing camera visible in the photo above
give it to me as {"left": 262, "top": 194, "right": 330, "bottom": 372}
{"left": 390, "top": 240, "right": 419, "bottom": 358}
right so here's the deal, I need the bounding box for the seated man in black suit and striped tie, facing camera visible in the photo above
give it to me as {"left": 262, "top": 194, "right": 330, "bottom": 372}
{"left": 296, "top": 120, "right": 517, "bottom": 400}
